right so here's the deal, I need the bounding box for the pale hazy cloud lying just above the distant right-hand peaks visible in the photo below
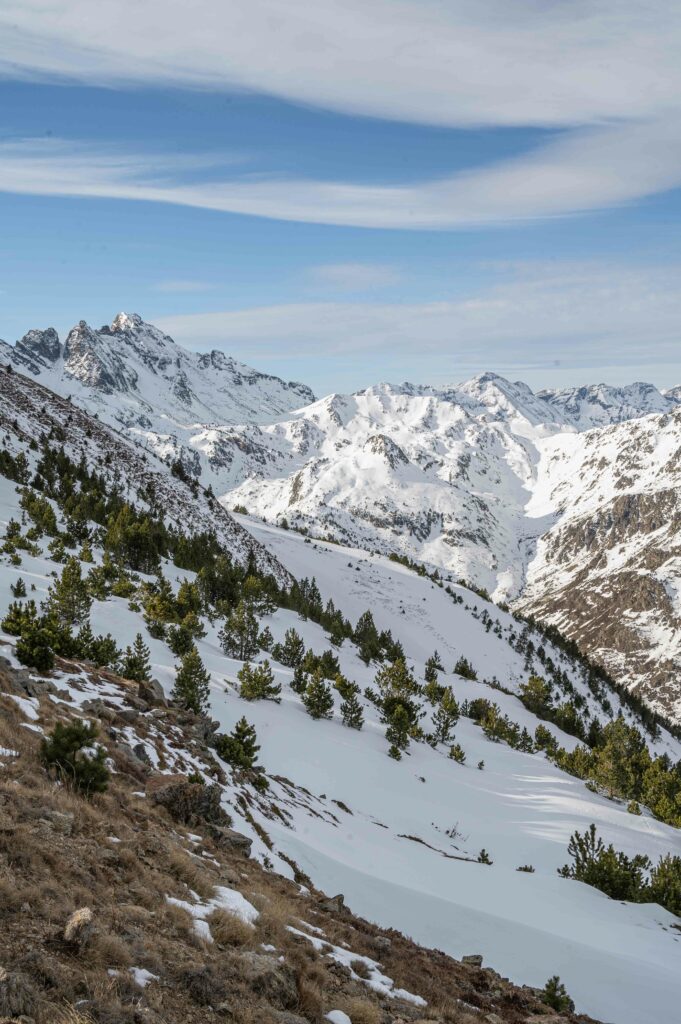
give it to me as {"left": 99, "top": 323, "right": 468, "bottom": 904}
{"left": 156, "top": 263, "right": 681, "bottom": 386}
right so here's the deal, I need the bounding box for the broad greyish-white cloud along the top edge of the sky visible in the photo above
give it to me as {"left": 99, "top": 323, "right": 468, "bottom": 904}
{"left": 0, "top": 0, "right": 681, "bottom": 126}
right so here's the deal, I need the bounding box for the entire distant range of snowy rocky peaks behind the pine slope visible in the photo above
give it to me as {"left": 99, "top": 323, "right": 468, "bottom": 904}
{"left": 0, "top": 313, "right": 681, "bottom": 717}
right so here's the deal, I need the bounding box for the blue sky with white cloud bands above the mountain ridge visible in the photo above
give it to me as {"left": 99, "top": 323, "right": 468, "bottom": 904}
{"left": 0, "top": 0, "right": 681, "bottom": 394}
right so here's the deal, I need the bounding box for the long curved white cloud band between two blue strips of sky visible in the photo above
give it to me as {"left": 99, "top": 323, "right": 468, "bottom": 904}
{"left": 0, "top": 117, "right": 681, "bottom": 229}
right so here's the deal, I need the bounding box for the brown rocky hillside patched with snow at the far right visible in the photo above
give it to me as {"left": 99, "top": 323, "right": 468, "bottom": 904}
{"left": 518, "top": 409, "right": 681, "bottom": 720}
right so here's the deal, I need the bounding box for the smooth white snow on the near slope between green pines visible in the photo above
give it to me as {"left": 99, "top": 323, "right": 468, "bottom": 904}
{"left": 0, "top": 478, "right": 681, "bottom": 1024}
